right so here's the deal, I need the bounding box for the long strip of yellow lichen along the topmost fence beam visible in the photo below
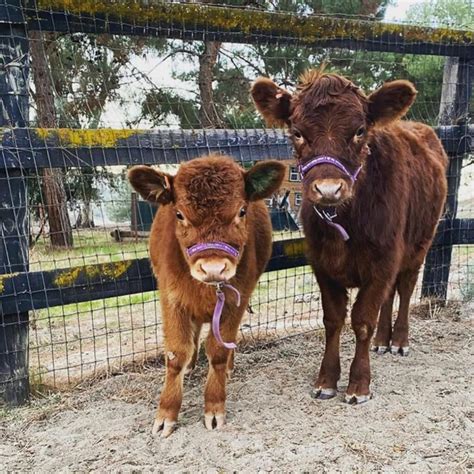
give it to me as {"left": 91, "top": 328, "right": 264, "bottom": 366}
{"left": 38, "top": 0, "right": 474, "bottom": 45}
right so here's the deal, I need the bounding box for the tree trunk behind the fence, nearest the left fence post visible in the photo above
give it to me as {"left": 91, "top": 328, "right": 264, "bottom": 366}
{"left": 29, "top": 31, "right": 73, "bottom": 247}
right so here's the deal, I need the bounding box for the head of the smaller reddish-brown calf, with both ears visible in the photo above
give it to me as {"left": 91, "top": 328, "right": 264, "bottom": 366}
{"left": 128, "top": 156, "right": 285, "bottom": 283}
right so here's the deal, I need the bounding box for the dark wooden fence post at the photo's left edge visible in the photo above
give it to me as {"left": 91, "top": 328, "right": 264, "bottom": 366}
{"left": 0, "top": 0, "right": 29, "bottom": 406}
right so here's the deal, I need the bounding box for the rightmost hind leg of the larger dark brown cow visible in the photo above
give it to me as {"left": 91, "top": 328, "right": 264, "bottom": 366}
{"left": 391, "top": 269, "right": 418, "bottom": 356}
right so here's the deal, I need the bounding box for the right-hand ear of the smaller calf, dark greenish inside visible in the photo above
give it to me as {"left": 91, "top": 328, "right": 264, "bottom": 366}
{"left": 245, "top": 160, "right": 286, "bottom": 201}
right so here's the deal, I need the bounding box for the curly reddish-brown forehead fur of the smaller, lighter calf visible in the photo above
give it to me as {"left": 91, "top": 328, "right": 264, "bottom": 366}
{"left": 173, "top": 156, "right": 245, "bottom": 217}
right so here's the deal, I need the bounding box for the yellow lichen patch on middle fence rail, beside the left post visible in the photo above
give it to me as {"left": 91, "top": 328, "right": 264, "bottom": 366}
{"left": 35, "top": 128, "right": 140, "bottom": 148}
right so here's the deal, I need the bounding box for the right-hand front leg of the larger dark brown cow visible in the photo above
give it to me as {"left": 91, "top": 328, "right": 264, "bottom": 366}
{"left": 346, "top": 283, "right": 390, "bottom": 404}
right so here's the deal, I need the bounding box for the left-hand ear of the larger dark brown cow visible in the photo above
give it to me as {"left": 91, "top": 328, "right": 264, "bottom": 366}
{"left": 250, "top": 77, "right": 291, "bottom": 127}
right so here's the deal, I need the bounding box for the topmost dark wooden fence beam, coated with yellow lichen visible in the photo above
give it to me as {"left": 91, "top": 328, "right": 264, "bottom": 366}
{"left": 24, "top": 0, "right": 474, "bottom": 58}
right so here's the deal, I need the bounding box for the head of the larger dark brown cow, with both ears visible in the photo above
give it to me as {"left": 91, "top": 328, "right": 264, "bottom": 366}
{"left": 251, "top": 70, "right": 416, "bottom": 207}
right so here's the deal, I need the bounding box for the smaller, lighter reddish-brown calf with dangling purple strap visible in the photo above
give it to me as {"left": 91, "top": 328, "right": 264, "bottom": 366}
{"left": 129, "top": 155, "right": 285, "bottom": 437}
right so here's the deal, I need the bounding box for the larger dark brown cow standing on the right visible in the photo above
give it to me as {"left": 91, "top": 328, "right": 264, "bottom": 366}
{"left": 252, "top": 71, "right": 447, "bottom": 403}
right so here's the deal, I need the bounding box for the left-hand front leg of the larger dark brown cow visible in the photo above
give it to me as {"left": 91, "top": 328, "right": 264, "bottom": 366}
{"left": 312, "top": 276, "right": 347, "bottom": 400}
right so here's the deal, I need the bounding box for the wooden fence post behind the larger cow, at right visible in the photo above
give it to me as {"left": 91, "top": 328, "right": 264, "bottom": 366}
{"left": 421, "top": 57, "right": 474, "bottom": 301}
